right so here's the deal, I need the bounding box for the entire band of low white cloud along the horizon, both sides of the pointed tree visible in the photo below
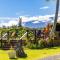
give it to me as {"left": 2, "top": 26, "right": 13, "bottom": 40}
{"left": 0, "top": 14, "right": 60, "bottom": 27}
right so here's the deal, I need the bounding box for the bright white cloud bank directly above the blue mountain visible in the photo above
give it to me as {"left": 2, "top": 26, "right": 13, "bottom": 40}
{"left": 20, "top": 14, "right": 54, "bottom": 22}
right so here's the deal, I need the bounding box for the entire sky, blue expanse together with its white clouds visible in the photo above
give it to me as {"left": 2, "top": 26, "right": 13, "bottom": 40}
{"left": 0, "top": 0, "right": 60, "bottom": 26}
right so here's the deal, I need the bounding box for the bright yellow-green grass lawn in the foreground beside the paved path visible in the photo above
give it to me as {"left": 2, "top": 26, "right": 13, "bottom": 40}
{"left": 0, "top": 47, "right": 60, "bottom": 60}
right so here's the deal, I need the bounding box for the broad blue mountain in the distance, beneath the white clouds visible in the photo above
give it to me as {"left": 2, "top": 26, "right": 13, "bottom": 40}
{"left": 22, "top": 20, "right": 50, "bottom": 28}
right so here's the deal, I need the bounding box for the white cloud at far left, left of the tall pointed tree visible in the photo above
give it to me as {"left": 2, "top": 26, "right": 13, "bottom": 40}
{"left": 0, "top": 17, "right": 18, "bottom": 27}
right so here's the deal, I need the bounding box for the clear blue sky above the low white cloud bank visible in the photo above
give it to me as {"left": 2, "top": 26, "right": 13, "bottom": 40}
{"left": 0, "top": 0, "right": 55, "bottom": 17}
